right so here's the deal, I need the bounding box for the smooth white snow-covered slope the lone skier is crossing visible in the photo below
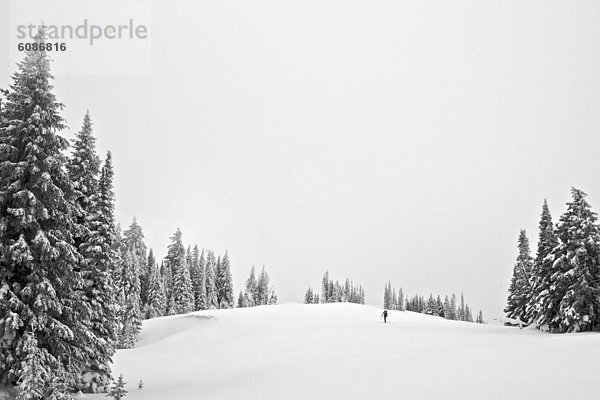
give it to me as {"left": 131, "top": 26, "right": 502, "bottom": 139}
{"left": 87, "top": 303, "right": 600, "bottom": 400}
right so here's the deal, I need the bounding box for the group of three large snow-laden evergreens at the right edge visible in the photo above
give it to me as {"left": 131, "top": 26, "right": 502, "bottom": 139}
{"left": 504, "top": 188, "right": 600, "bottom": 332}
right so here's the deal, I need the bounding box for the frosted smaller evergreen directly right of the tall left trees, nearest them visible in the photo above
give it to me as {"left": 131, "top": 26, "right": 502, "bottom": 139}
{"left": 117, "top": 249, "right": 142, "bottom": 349}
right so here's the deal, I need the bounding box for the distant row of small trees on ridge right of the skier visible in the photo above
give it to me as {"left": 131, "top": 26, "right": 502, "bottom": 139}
{"left": 383, "top": 282, "right": 485, "bottom": 324}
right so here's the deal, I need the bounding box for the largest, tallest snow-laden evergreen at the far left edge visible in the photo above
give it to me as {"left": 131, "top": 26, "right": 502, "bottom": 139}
{"left": 0, "top": 31, "right": 93, "bottom": 398}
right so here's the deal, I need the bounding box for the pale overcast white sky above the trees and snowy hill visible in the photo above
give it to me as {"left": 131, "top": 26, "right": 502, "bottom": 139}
{"left": 0, "top": 0, "right": 600, "bottom": 318}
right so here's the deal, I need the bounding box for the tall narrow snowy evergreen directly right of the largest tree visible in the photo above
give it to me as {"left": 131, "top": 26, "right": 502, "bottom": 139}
{"left": 67, "top": 111, "right": 117, "bottom": 391}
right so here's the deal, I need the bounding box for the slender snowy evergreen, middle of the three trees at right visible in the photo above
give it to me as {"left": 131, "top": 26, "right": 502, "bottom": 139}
{"left": 527, "top": 199, "right": 558, "bottom": 326}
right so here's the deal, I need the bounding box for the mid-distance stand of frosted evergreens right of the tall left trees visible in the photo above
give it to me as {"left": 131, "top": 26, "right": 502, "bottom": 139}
{"left": 118, "top": 223, "right": 244, "bottom": 342}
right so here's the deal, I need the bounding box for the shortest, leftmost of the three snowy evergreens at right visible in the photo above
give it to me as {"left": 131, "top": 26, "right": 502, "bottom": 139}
{"left": 504, "top": 229, "right": 533, "bottom": 324}
